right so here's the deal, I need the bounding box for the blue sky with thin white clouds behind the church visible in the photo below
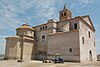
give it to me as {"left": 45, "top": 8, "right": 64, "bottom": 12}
{"left": 0, "top": 0, "right": 100, "bottom": 54}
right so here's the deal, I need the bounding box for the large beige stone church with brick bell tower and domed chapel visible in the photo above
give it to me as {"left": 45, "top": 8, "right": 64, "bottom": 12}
{"left": 5, "top": 5, "right": 97, "bottom": 62}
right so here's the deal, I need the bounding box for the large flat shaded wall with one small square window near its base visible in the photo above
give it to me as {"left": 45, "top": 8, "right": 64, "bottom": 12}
{"left": 47, "top": 30, "right": 80, "bottom": 61}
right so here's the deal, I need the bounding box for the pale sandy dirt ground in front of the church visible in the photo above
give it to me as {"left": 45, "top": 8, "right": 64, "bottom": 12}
{"left": 0, "top": 60, "right": 100, "bottom": 67}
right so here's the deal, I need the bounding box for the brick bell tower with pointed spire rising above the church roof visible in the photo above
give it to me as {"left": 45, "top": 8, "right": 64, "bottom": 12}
{"left": 59, "top": 4, "right": 72, "bottom": 21}
